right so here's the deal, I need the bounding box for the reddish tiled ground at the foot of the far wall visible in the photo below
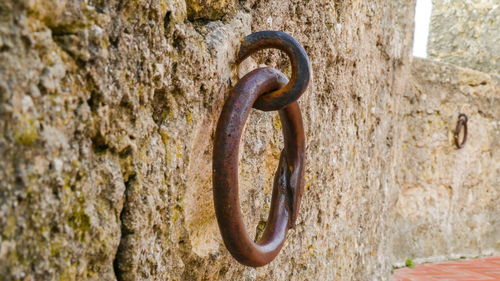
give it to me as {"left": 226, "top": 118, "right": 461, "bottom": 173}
{"left": 393, "top": 257, "right": 500, "bottom": 281}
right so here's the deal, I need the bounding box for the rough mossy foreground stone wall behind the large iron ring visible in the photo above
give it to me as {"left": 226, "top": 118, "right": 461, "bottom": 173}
{"left": 0, "top": 0, "right": 414, "bottom": 281}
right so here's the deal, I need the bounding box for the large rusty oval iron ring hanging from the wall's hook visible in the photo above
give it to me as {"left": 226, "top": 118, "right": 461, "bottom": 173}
{"left": 212, "top": 67, "right": 305, "bottom": 267}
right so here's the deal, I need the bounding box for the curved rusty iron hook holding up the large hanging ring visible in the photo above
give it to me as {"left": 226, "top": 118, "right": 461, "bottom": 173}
{"left": 236, "top": 31, "right": 311, "bottom": 111}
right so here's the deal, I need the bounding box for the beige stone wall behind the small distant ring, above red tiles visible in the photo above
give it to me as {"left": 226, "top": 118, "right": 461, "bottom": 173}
{"left": 391, "top": 59, "right": 500, "bottom": 262}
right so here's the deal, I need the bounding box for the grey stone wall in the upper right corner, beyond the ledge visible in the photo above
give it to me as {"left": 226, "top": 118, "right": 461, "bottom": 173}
{"left": 428, "top": 0, "right": 500, "bottom": 74}
